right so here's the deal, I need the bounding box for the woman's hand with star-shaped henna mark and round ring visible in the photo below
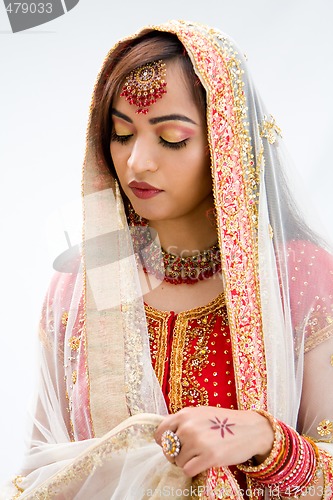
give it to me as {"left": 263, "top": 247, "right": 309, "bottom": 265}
{"left": 155, "top": 406, "right": 274, "bottom": 477}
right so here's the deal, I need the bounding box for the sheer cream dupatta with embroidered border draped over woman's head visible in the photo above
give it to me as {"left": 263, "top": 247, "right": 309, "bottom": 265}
{"left": 3, "top": 21, "right": 333, "bottom": 499}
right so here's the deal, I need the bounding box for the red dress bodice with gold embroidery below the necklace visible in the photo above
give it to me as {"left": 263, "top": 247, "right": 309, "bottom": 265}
{"left": 145, "top": 294, "right": 235, "bottom": 412}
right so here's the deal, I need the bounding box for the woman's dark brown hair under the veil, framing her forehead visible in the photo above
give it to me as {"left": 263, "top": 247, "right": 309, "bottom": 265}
{"left": 92, "top": 31, "right": 206, "bottom": 176}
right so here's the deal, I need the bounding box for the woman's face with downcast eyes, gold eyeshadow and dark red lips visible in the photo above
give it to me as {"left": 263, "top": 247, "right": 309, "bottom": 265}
{"left": 110, "top": 62, "right": 213, "bottom": 221}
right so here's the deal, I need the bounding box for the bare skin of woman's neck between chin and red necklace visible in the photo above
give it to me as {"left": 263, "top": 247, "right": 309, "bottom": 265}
{"left": 149, "top": 209, "right": 217, "bottom": 257}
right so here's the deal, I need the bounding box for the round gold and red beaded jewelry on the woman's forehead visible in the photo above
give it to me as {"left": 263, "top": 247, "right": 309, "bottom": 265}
{"left": 120, "top": 60, "right": 166, "bottom": 114}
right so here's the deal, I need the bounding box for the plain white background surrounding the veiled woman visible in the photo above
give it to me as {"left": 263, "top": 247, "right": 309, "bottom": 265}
{"left": 0, "top": 0, "right": 333, "bottom": 484}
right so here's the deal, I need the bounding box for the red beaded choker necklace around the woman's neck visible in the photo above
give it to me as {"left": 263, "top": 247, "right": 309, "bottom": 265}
{"left": 131, "top": 226, "right": 221, "bottom": 285}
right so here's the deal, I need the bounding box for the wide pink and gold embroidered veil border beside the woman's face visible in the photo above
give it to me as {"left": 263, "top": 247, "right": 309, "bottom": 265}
{"left": 153, "top": 21, "right": 267, "bottom": 409}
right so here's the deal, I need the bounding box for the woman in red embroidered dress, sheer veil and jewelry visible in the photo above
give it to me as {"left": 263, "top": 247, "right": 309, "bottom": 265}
{"left": 3, "top": 22, "right": 333, "bottom": 499}
